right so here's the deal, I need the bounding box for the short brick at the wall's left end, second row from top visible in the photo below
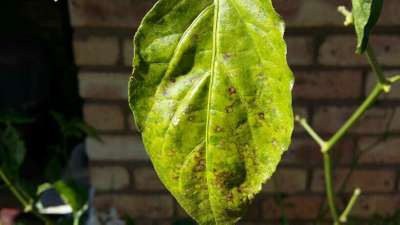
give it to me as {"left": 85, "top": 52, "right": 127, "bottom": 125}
{"left": 74, "top": 36, "right": 119, "bottom": 66}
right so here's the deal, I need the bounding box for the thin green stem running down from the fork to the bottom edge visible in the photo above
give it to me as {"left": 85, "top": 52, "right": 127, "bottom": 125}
{"left": 322, "top": 152, "right": 339, "bottom": 224}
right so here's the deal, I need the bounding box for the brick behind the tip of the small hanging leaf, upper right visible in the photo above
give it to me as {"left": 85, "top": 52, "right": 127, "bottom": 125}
{"left": 318, "top": 35, "right": 400, "bottom": 66}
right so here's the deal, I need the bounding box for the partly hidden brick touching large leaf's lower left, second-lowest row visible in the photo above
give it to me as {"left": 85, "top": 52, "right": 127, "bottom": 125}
{"left": 133, "top": 168, "right": 166, "bottom": 191}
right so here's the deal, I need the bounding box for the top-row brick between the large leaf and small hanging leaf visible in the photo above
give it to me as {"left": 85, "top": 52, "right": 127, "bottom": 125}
{"left": 274, "top": 0, "right": 349, "bottom": 27}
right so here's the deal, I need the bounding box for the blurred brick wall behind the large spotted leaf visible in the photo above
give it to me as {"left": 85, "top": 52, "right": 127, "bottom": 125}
{"left": 70, "top": 0, "right": 400, "bottom": 225}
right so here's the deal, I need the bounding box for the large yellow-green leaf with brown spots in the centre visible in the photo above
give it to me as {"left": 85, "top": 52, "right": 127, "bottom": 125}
{"left": 129, "top": 0, "right": 293, "bottom": 225}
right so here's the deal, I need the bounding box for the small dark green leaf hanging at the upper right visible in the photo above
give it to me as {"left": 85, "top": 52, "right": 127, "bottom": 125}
{"left": 352, "top": 0, "right": 383, "bottom": 54}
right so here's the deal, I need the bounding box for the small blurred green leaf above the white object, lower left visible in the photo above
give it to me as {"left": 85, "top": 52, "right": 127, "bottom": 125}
{"left": 53, "top": 181, "right": 88, "bottom": 213}
